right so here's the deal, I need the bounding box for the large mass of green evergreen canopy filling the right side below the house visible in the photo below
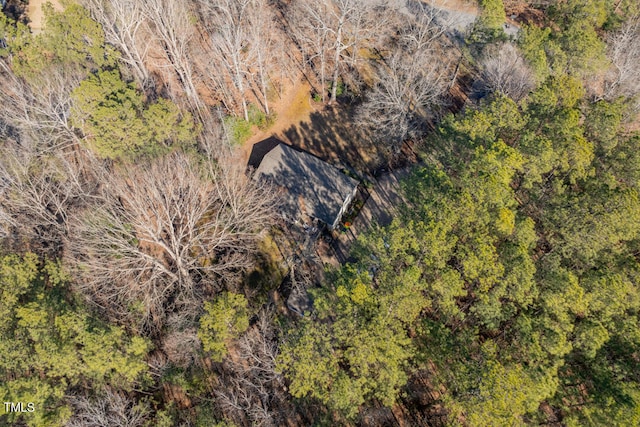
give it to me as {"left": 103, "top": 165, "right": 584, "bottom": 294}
{"left": 281, "top": 70, "right": 640, "bottom": 426}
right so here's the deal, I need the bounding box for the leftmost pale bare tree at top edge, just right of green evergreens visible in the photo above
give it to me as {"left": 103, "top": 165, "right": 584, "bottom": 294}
{"left": 83, "top": 0, "right": 152, "bottom": 88}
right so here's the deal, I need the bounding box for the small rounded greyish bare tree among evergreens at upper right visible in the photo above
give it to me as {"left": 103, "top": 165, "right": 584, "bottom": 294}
{"left": 480, "top": 43, "right": 535, "bottom": 101}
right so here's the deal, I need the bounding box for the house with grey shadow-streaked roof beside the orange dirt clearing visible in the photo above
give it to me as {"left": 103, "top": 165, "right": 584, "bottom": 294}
{"left": 250, "top": 138, "right": 358, "bottom": 229}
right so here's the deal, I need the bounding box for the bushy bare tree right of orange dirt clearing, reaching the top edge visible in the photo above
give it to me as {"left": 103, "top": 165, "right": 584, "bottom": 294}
{"left": 356, "top": 2, "right": 453, "bottom": 155}
